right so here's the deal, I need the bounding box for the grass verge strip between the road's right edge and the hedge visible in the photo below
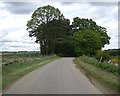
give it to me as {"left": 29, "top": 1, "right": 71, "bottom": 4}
{"left": 73, "top": 57, "right": 120, "bottom": 93}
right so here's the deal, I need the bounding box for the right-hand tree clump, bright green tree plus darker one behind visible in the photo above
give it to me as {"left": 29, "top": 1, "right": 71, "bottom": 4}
{"left": 72, "top": 17, "right": 110, "bottom": 55}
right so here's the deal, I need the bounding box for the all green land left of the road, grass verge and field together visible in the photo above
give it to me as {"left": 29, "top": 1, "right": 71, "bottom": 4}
{"left": 2, "top": 53, "right": 59, "bottom": 90}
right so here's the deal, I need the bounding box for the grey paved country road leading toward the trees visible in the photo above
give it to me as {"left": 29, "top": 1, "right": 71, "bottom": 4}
{"left": 4, "top": 58, "right": 102, "bottom": 94}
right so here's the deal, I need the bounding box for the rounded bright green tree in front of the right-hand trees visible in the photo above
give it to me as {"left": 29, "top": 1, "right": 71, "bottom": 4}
{"left": 73, "top": 29, "right": 101, "bottom": 56}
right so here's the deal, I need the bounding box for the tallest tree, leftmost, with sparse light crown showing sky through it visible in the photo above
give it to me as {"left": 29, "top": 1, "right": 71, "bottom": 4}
{"left": 27, "top": 5, "right": 65, "bottom": 55}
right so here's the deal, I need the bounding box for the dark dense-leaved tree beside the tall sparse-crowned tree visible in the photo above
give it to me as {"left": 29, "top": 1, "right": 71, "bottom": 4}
{"left": 40, "top": 19, "right": 72, "bottom": 54}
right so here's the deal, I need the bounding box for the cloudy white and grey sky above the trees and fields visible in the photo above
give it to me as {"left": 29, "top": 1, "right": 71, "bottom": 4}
{"left": 0, "top": 2, "right": 120, "bottom": 51}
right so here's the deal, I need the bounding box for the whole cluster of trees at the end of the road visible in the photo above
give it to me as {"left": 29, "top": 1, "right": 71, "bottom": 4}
{"left": 27, "top": 5, "right": 110, "bottom": 56}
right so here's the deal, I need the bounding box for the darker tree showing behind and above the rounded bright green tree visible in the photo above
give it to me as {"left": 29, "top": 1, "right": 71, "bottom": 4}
{"left": 72, "top": 17, "right": 110, "bottom": 47}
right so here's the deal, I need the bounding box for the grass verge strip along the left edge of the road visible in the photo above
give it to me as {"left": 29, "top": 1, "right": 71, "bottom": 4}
{"left": 2, "top": 55, "right": 59, "bottom": 90}
